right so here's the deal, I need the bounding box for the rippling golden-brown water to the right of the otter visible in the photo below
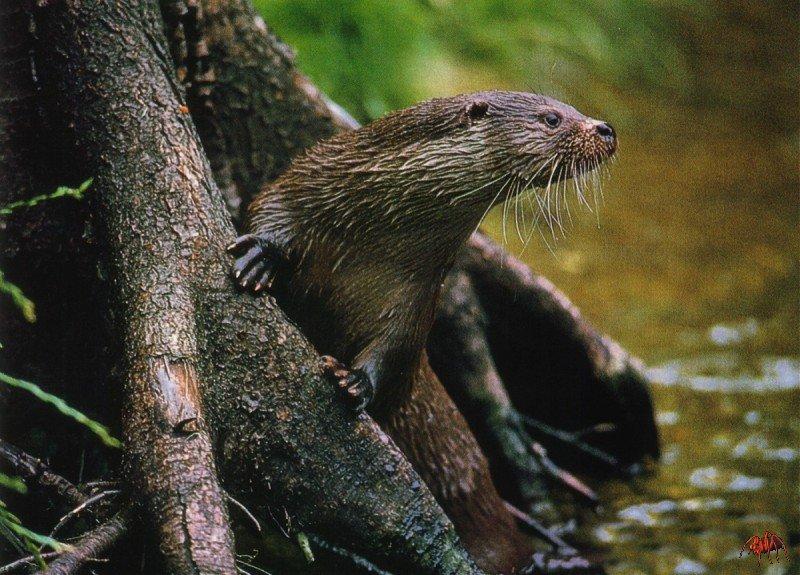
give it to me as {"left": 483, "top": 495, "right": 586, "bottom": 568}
{"left": 488, "top": 37, "right": 800, "bottom": 575}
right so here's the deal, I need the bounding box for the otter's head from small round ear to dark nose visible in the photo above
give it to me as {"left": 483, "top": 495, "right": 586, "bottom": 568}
{"left": 456, "top": 92, "right": 617, "bottom": 196}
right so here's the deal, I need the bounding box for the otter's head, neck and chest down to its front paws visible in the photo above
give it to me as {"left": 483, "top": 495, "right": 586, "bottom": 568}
{"left": 230, "top": 92, "right": 615, "bottom": 410}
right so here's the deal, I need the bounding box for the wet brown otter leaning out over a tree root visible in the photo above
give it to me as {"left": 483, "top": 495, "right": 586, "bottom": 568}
{"left": 228, "top": 91, "right": 617, "bottom": 572}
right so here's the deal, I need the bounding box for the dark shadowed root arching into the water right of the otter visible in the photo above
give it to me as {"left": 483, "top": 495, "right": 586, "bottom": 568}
{"left": 457, "top": 234, "right": 659, "bottom": 470}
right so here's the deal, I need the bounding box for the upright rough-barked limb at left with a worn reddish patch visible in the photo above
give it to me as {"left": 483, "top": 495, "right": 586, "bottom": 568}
{"left": 32, "top": 3, "right": 235, "bottom": 573}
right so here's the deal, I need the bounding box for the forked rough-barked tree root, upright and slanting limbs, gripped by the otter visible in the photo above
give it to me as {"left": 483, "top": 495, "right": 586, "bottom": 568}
{"left": 3, "top": 2, "right": 478, "bottom": 573}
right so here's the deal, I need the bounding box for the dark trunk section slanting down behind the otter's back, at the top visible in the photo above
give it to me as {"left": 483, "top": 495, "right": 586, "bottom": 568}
{"left": 162, "top": 0, "right": 357, "bottom": 223}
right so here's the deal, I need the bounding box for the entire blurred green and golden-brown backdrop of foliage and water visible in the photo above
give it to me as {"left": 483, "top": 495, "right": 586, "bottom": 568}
{"left": 256, "top": 0, "right": 800, "bottom": 575}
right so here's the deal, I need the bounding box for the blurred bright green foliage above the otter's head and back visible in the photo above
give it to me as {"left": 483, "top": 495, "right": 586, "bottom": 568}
{"left": 256, "top": 0, "right": 694, "bottom": 120}
